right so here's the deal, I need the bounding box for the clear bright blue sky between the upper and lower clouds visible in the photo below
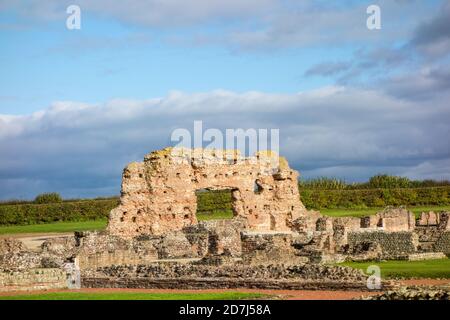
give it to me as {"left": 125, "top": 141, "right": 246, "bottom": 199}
{"left": 0, "top": 6, "right": 344, "bottom": 114}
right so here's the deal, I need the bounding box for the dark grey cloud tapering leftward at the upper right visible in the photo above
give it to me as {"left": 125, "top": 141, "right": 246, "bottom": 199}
{"left": 298, "top": 1, "right": 450, "bottom": 101}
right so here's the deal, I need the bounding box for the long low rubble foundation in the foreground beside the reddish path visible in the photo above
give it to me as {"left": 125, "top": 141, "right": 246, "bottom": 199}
{"left": 82, "top": 262, "right": 376, "bottom": 290}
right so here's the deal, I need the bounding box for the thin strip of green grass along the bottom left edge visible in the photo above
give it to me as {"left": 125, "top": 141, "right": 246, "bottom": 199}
{"left": 0, "top": 292, "right": 268, "bottom": 300}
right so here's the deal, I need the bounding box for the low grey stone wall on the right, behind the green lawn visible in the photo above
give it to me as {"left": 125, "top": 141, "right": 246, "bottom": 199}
{"left": 348, "top": 231, "right": 418, "bottom": 259}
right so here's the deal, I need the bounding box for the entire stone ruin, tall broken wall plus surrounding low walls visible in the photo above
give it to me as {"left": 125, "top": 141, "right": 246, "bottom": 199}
{"left": 0, "top": 148, "right": 450, "bottom": 290}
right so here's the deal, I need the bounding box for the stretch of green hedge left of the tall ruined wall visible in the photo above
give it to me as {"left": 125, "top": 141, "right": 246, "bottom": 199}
{"left": 0, "top": 199, "right": 119, "bottom": 225}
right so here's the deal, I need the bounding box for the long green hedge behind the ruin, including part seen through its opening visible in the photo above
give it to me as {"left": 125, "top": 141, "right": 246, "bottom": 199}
{"left": 0, "top": 186, "right": 450, "bottom": 225}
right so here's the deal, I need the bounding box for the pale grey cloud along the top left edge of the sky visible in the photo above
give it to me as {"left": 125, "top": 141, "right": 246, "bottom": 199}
{"left": 0, "top": 0, "right": 277, "bottom": 27}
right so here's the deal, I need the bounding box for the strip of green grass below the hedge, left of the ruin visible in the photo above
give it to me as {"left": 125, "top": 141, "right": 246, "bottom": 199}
{"left": 0, "top": 220, "right": 107, "bottom": 234}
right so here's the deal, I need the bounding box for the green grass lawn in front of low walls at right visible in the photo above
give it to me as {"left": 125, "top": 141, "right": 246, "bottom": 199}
{"left": 339, "top": 259, "right": 450, "bottom": 279}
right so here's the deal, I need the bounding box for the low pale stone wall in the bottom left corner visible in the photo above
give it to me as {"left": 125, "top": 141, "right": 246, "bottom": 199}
{"left": 0, "top": 268, "right": 68, "bottom": 292}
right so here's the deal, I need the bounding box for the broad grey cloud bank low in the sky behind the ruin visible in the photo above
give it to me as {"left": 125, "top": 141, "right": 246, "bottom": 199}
{"left": 0, "top": 87, "right": 450, "bottom": 198}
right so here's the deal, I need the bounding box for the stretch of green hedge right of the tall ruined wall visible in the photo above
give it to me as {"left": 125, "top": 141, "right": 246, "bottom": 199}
{"left": 300, "top": 186, "right": 450, "bottom": 209}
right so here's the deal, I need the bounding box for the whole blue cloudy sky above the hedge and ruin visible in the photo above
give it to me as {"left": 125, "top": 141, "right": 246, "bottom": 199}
{"left": 0, "top": 0, "right": 450, "bottom": 199}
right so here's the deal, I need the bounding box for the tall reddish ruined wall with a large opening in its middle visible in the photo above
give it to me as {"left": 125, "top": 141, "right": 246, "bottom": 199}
{"left": 108, "top": 148, "right": 306, "bottom": 238}
